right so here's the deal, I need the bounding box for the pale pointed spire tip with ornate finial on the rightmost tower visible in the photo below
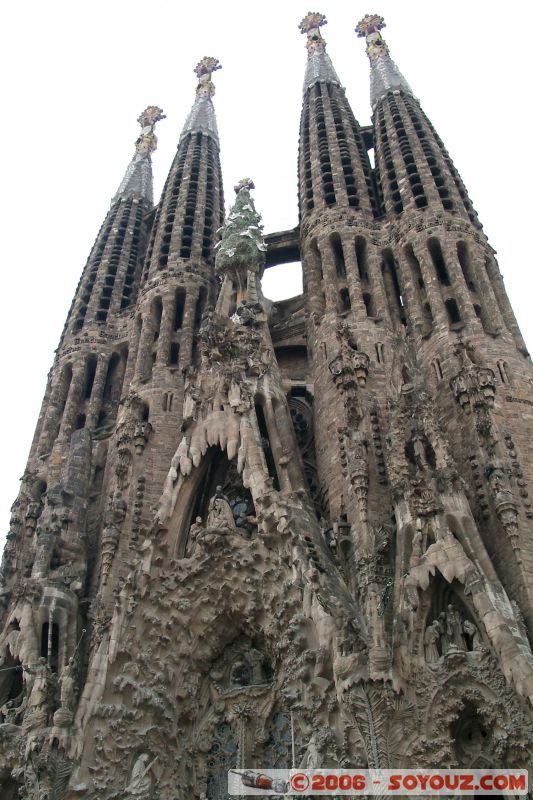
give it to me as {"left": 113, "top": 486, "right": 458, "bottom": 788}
{"left": 355, "top": 14, "right": 413, "bottom": 108}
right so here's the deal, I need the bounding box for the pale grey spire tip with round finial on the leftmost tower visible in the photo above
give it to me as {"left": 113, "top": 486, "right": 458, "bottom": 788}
{"left": 113, "top": 106, "right": 165, "bottom": 205}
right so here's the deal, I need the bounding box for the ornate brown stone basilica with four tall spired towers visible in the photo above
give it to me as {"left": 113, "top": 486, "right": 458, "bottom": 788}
{"left": 0, "top": 13, "right": 533, "bottom": 800}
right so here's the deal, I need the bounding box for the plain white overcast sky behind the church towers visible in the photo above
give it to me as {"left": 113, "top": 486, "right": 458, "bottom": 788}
{"left": 0, "top": 0, "right": 533, "bottom": 552}
